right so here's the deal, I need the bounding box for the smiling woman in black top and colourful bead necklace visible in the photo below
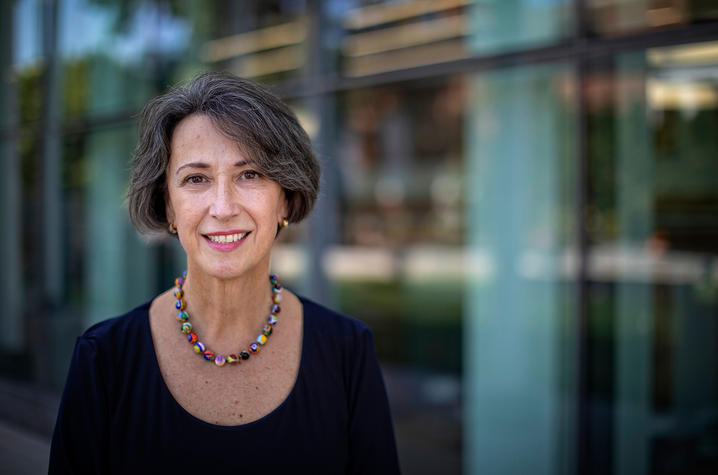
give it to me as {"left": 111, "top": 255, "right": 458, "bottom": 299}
{"left": 50, "top": 73, "right": 398, "bottom": 473}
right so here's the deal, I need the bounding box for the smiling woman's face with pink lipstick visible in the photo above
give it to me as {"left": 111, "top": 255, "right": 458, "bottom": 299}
{"left": 167, "top": 114, "right": 287, "bottom": 278}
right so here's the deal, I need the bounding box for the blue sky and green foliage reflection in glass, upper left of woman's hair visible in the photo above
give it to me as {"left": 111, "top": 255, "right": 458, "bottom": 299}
{"left": 57, "top": 0, "right": 190, "bottom": 119}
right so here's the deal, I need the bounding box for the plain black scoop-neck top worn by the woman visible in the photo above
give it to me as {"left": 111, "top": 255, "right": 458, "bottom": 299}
{"left": 50, "top": 298, "right": 399, "bottom": 475}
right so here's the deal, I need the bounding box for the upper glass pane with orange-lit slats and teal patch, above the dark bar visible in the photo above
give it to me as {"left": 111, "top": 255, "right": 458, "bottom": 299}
{"left": 334, "top": 0, "right": 573, "bottom": 76}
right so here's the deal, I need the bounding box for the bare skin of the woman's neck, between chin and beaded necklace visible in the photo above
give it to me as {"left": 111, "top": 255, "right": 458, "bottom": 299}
{"left": 183, "top": 262, "right": 272, "bottom": 351}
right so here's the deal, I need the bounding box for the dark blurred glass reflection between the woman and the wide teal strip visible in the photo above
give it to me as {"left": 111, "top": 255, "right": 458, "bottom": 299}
{"left": 338, "top": 76, "right": 466, "bottom": 473}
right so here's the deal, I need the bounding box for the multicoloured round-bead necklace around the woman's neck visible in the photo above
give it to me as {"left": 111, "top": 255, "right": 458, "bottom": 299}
{"left": 174, "top": 271, "right": 282, "bottom": 366}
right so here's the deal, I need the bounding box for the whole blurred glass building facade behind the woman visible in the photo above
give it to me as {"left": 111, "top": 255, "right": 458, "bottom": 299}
{"left": 0, "top": 0, "right": 718, "bottom": 475}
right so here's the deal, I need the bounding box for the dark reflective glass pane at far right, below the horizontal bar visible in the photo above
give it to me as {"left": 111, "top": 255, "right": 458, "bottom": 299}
{"left": 589, "top": 43, "right": 718, "bottom": 474}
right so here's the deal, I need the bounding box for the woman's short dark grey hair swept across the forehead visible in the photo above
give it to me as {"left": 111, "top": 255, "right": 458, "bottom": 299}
{"left": 127, "top": 73, "right": 320, "bottom": 233}
